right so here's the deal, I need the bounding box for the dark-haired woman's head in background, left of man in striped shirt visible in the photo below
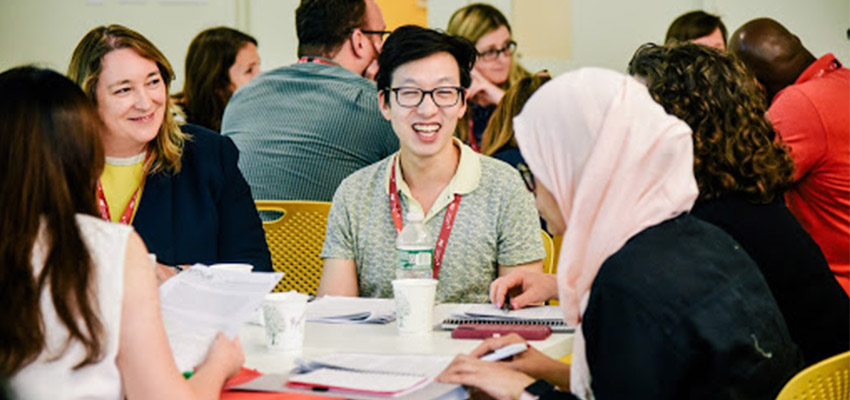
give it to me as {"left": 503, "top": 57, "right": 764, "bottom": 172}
{"left": 174, "top": 26, "right": 260, "bottom": 132}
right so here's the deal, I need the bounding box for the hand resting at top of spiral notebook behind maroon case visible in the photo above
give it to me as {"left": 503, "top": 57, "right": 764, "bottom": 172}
{"left": 490, "top": 270, "right": 558, "bottom": 310}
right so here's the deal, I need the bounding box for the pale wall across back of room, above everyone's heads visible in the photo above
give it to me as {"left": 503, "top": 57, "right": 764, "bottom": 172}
{"left": 0, "top": 0, "right": 850, "bottom": 83}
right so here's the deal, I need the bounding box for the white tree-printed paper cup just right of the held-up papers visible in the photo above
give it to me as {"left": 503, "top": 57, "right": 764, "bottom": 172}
{"left": 263, "top": 292, "right": 308, "bottom": 352}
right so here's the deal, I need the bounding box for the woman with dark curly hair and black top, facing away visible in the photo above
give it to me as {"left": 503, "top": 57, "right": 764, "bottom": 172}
{"left": 629, "top": 44, "right": 850, "bottom": 364}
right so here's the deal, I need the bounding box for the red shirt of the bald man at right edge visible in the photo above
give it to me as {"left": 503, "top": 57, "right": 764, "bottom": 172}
{"left": 767, "top": 54, "right": 850, "bottom": 294}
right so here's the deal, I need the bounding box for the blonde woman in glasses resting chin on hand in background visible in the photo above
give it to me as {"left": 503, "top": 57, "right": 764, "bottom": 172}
{"left": 446, "top": 3, "right": 530, "bottom": 151}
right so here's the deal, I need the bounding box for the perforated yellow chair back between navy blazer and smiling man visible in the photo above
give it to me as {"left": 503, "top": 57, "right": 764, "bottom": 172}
{"left": 256, "top": 200, "right": 331, "bottom": 295}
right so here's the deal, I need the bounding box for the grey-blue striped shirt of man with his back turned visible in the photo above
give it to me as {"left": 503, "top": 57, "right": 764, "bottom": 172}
{"left": 221, "top": 58, "right": 398, "bottom": 201}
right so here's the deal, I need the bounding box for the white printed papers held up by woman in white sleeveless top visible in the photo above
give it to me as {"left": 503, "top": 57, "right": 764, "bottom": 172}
{"left": 159, "top": 265, "right": 283, "bottom": 371}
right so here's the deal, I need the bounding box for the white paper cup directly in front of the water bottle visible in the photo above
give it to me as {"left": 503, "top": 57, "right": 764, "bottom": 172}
{"left": 393, "top": 279, "right": 437, "bottom": 335}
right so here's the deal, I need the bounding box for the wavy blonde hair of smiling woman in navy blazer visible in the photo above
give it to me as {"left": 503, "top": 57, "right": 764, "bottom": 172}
{"left": 68, "top": 25, "right": 189, "bottom": 174}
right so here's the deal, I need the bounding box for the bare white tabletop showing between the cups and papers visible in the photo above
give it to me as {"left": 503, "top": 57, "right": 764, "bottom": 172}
{"left": 239, "top": 304, "right": 573, "bottom": 373}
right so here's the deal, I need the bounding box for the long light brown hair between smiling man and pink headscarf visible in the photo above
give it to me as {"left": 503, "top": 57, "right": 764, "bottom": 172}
{"left": 481, "top": 72, "right": 552, "bottom": 156}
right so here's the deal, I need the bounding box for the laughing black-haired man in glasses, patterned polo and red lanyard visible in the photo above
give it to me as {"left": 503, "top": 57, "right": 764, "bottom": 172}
{"left": 319, "top": 26, "right": 545, "bottom": 303}
